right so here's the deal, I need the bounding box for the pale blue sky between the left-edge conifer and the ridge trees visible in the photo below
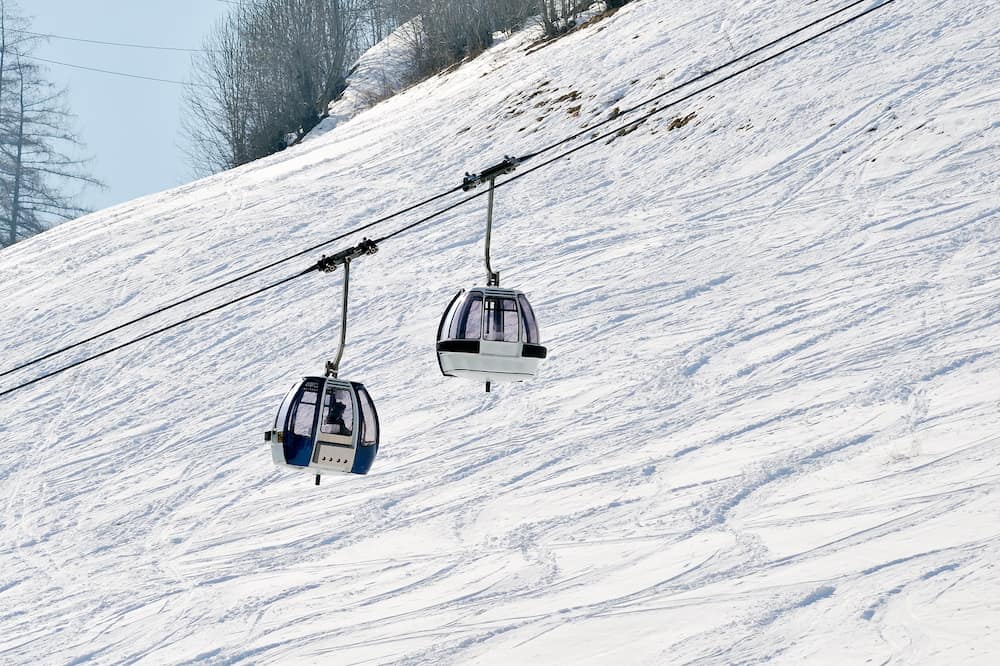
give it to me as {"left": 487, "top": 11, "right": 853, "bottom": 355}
{"left": 16, "top": 0, "right": 232, "bottom": 209}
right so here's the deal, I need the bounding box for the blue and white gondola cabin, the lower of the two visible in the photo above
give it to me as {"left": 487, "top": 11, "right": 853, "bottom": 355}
{"left": 264, "top": 377, "right": 379, "bottom": 483}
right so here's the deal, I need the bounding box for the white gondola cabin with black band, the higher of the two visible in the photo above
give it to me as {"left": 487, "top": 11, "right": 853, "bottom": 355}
{"left": 437, "top": 287, "right": 548, "bottom": 390}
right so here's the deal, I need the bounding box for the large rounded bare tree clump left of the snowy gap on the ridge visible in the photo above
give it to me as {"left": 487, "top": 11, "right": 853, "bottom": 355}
{"left": 186, "top": 0, "right": 364, "bottom": 172}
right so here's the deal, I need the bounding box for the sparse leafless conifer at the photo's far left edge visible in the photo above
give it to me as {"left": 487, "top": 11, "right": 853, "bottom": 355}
{"left": 0, "top": 0, "right": 100, "bottom": 247}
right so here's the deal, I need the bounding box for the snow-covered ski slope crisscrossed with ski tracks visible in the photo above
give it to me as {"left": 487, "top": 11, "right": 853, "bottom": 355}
{"left": 0, "top": 0, "right": 1000, "bottom": 664}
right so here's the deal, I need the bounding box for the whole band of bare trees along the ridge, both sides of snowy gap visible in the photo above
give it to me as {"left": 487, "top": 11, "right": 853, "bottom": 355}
{"left": 185, "top": 0, "right": 556, "bottom": 173}
